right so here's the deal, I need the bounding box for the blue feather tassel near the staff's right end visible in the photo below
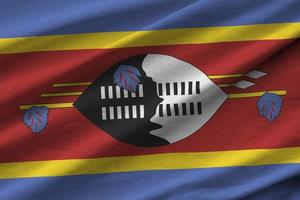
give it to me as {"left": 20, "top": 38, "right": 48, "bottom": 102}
{"left": 257, "top": 93, "right": 283, "bottom": 122}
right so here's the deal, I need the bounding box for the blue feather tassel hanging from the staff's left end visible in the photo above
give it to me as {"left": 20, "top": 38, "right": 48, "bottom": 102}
{"left": 23, "top": 106, "right": 48, "bottom": 133}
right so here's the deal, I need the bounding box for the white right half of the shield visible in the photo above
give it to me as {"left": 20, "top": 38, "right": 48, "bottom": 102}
{"left": 142, "top": 54, "right": 227, "bottom": 143}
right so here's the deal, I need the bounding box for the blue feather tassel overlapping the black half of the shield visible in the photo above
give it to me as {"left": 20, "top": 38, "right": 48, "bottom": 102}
{"left": 114, "top": 65, "right": 141, "bottom": 93}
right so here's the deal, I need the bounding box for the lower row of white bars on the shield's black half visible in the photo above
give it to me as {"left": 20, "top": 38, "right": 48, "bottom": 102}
{"left": 101, "top": 105, "right": 145, "bottom": 120}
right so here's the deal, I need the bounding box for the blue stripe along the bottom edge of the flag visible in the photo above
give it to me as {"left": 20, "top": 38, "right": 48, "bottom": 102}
{"left": 0, "top": 164, "right": 300, "bottom": 200}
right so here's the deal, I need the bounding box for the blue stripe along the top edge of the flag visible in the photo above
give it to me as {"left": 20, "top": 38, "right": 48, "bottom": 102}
{"left": 0, "top": 0, "right": 300, "bottom": 37}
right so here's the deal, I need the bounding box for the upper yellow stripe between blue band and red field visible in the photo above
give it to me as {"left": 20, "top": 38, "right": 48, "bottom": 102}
{"left": 0, "top": 22, "right": 300, "bottom": 54}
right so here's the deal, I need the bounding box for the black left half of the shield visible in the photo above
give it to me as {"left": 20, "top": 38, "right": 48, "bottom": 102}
{"left": 74, "top": 55, "right": 169, "bottom": 147}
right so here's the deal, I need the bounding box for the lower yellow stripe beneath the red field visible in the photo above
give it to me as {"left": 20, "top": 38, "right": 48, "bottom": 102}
{"left": 0, "top": 147, "right": 300, "bottom": 179}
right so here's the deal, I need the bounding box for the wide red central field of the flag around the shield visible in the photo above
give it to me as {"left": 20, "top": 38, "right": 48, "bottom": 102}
{"left": 0, "top": 40, "right": 300, "bottom": 162}
